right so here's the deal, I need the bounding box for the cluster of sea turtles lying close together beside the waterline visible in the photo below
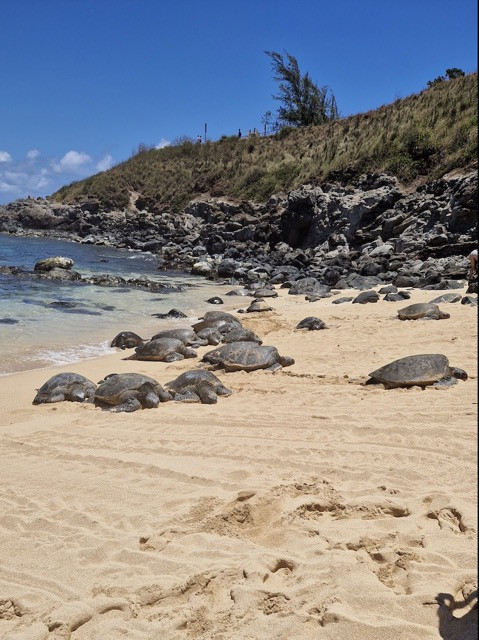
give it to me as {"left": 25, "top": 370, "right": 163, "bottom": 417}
{"left": 33, "top": 311, "right": 294, "bottom": 412}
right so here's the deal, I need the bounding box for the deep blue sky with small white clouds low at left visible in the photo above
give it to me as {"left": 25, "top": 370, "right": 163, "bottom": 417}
{"left": 0, "top": 0, "right": 477, "bottom": 203}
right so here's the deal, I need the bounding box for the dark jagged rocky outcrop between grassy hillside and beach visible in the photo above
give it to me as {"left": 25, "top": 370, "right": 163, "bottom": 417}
{"left": 0, "top": 173, "right": 477, "bottom": 289}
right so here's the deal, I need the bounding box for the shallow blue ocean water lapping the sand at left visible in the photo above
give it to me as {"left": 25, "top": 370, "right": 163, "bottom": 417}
{"left": 0, "top": 234, "right": 229, "bottom": 375}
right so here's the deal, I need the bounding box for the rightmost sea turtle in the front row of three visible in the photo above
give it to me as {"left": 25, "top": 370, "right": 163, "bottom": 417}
{"left": 165, "top": 369, "right": 233, "bottom": 404}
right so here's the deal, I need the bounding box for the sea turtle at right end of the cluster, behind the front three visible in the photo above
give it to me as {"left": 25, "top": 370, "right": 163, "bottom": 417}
{"left": 202, "top": 342, "right": 294, "bottom": 371}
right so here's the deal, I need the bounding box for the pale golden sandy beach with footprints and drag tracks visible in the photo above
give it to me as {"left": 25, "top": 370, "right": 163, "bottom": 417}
{"left": 0, "top": 290, "right": 477, "bottom": 640}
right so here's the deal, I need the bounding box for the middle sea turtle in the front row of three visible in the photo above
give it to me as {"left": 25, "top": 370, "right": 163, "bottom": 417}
{"left": 93, "top": 373, "right": 172, "bottom": 412}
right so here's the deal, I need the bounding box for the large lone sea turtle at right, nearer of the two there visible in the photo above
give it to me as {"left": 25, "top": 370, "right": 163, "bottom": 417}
{"left": 366, "top": 353, "right": 467, "bottom": 389}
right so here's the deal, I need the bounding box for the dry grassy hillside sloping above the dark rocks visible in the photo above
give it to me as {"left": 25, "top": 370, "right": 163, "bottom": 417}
{"left": 52, "top": 73, "right": 477, "bottom": 211}
